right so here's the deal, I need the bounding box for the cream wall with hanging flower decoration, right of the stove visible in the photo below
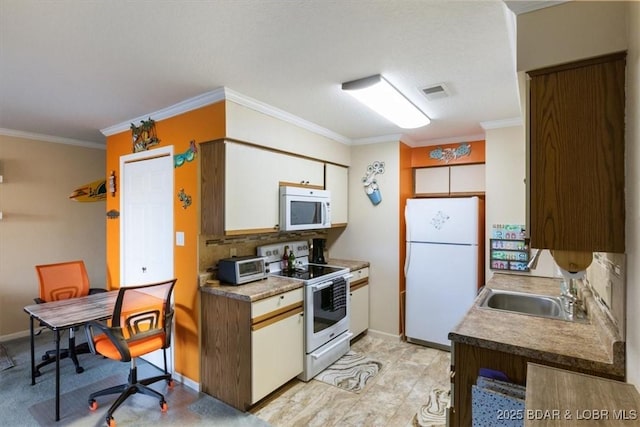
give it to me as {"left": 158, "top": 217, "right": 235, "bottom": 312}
{"left": 328, "top": 142, "right": 400, "bottom": 337}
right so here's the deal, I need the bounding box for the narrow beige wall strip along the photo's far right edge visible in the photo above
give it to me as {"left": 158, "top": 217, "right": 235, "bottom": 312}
{"left": 625, "top": 2, "right": 640, "bottom": 389}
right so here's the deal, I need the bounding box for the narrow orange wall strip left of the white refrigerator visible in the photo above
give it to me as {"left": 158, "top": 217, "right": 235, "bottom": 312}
{"left": 398, "top": 141, "right": 415, "bottom": 336}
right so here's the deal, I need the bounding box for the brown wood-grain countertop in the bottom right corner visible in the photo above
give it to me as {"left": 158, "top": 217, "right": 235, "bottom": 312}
{"left": 523, "top": 363, "right": 640, "bottom": 427}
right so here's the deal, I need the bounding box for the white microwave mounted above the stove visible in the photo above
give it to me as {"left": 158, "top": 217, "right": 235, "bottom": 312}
{"left": 280, "top": 186, "right": 331, "bottom": 231}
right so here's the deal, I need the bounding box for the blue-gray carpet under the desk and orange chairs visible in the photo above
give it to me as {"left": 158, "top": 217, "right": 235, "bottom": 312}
{"left": 0, "top": 332, "right": 269, "bottom": 427}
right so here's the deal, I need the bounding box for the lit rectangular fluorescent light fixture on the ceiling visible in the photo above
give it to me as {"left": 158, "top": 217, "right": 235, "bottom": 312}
{"left": 342, "top": 74, "right": 431, "bottom": 129}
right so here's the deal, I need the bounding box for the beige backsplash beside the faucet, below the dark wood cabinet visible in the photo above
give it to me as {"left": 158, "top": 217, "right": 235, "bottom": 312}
{"left": 587, "top": 252, "right": 626, "bottom": 337}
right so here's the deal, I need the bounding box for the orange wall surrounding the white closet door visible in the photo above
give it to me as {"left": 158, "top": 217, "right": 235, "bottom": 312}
{"left": 106, "top": 102, "right": 226, "bottom": 382}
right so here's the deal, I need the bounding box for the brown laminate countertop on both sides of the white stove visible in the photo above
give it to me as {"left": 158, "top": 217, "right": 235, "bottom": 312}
{"left": 200, "top": 258, "right": 369, "bottom": 302}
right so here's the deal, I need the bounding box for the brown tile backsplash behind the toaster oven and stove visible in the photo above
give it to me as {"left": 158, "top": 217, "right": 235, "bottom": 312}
{"left": 198, "top": 230, "right": 327, "bottom": 272}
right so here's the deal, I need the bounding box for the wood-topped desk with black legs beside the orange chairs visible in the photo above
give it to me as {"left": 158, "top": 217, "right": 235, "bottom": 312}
{"left": 24, "top": 291, "right": 118, "bottom": 421}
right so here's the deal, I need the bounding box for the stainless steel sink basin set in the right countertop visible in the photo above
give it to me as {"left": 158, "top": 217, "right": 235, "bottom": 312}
{"left": 480, "top": 289, "right": 569, "bottom": 320}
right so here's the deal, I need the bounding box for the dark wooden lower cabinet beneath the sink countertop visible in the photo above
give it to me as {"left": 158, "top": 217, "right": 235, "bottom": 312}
{"left": 449, "top": 342, "right": 624, "bottom": 427}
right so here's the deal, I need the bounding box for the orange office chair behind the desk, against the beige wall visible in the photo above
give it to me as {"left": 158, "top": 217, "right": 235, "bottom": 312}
{"left": 34, "top": 261, "right": 105, "bottom": 376}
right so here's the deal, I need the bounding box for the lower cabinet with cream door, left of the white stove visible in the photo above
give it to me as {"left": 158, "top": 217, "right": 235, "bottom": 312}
{"left": 200, "top": 289, "right": 304, "bottom": 411}
